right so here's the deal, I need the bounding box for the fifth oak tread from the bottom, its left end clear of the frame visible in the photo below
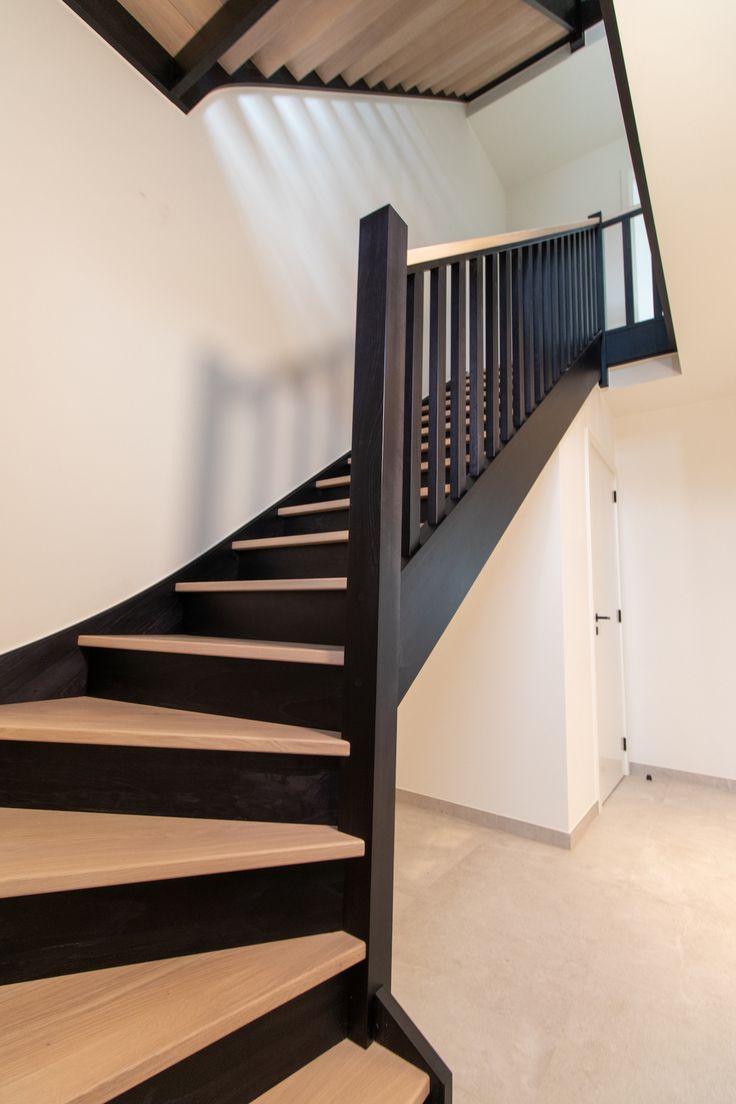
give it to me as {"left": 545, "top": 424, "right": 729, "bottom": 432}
{"left": 78, "top": 633, "right": 344, "bottom": 667}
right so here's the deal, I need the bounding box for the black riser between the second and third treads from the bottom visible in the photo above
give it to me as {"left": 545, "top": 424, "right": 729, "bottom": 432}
{"left": 0, "top": 862, "right": 344, "bottom": 985}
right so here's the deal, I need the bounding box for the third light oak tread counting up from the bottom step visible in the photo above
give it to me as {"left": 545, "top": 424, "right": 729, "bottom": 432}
{"left": 0, "top": 808, "right": 364, "bottom": 900}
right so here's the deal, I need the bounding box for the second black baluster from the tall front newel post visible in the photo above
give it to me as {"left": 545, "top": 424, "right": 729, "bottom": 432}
{"left": 427, "top": 265, "right": 447, "bottom": 526}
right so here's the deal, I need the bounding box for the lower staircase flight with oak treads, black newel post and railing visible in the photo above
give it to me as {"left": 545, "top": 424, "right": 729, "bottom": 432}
{"left": 0, "top": 208, "right": 675, "bottom": 1104}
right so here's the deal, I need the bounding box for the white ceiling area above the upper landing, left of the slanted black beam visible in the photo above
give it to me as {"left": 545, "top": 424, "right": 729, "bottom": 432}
{"left": 469, "top": 24, "right": 626, "bottom": 188}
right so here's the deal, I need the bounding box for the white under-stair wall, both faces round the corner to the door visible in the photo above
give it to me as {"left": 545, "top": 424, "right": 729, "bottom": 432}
{"left": 397, "top": 390, "right": 614, "bottom": 832}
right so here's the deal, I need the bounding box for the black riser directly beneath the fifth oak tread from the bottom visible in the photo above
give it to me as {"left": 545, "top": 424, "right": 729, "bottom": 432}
{"left": 86, "top": 648, "right": 343, "bottom": 732}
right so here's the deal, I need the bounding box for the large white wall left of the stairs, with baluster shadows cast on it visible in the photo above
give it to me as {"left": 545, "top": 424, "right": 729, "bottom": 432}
{"left": 0, "top": 0, "right": 505, "bottom": 650}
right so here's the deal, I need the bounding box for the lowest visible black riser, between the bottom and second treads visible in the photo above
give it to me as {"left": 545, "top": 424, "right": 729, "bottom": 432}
{"left": 109, "top": 970, "right": 352, "bottom": 1104}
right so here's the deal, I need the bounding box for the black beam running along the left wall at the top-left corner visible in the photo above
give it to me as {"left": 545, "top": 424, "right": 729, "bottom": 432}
{"left": 60, "top": 0, "right": 181, "bottom": 99}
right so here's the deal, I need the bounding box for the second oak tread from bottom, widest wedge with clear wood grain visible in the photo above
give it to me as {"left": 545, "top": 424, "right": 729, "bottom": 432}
{"left": 0, "top": 932, "right": 365, "bottom": 1104}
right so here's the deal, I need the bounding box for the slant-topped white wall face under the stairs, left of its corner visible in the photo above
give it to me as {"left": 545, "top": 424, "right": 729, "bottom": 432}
{"left": 397, "top": 456, "right": 567, "bottom": 831}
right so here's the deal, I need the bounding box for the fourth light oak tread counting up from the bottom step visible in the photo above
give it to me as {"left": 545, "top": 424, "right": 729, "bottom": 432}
{"left": 0, "top": 698, "right": 350, "bottom": 755}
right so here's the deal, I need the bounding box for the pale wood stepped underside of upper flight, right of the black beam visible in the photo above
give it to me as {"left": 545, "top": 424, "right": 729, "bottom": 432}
{"left": 218, "top": 0, "right": 565, "bottom": 95}
